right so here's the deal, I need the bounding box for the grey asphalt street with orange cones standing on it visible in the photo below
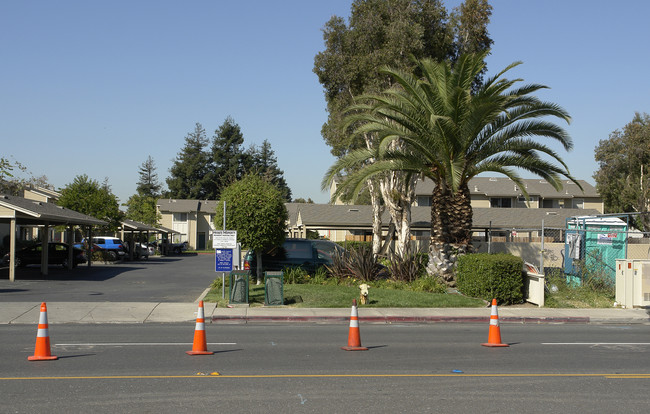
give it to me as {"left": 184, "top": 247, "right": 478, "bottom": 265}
{"left": 0, "top": 324, "right": 650, "bottom": 413}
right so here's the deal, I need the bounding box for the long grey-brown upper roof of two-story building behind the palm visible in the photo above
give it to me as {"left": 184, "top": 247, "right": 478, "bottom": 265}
{"left": 415, "top": 177, "right": 600, "bottom": 198}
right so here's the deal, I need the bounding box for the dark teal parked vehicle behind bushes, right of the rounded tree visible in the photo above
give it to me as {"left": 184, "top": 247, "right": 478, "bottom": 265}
{"left": 244, "top": 239, "right": 345, "bottom": 274}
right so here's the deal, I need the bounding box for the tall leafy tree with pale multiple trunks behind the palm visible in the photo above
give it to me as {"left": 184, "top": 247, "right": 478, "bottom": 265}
{"left": 314, "top": 0, "right": 492, "bottom": 253}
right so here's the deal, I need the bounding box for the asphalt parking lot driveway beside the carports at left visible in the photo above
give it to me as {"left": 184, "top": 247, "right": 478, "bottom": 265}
{"left": 0, "top": 254, "right": 218, "bottom": 302}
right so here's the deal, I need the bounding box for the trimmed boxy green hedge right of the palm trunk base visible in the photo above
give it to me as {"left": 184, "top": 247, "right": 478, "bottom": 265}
{"left": 456, "top": 253, "right": 524, "bottom": 304}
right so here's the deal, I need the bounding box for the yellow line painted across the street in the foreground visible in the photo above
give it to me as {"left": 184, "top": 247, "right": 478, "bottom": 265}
{"left": 0, "top": 372, "right": 650, "bottom": 381}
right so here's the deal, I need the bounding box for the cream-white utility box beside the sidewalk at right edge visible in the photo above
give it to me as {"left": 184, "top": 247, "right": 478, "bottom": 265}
{"left": 616, "top": 259, "right": 650, "bottom": 308}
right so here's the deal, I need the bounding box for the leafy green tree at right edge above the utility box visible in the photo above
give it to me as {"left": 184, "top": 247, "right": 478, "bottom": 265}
{"left": 593, "top": 112, "right": 650, "bottom": 232}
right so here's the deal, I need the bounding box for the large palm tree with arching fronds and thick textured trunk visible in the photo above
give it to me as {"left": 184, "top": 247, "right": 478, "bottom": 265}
{"left": 330, "top": 54, "right": 576, "bottom": 284}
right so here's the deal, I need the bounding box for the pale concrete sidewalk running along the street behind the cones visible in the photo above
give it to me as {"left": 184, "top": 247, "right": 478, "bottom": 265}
{"left": 0, "top": 302, "right": 650, "bottom": 325}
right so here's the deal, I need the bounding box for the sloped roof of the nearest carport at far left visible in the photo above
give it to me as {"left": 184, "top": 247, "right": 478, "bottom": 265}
{"left": 0, "top": 195, "right": 107, "bottom": 226}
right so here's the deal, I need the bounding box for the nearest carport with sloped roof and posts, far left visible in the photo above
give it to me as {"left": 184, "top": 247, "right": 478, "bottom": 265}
{"left": 0, "top": 195, "right": 107, "bottom": 282}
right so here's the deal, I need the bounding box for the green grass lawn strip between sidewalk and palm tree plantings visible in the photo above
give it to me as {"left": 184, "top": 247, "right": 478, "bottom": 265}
{"left": 203, "top": 278, "right": 485, "bottom": 308}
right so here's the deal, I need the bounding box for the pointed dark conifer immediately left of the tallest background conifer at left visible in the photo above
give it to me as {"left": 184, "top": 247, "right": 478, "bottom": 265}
{"left": 167, "top": 122, "right": 210, "bottom": 199}
